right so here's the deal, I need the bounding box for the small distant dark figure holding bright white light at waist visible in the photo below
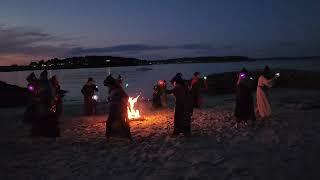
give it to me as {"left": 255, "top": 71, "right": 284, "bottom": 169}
{"left": 81, "top": 78, "right": 98, "bottom": 116}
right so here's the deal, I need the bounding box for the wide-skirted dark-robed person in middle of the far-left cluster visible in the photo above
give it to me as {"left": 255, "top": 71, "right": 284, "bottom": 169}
{"left": 31, "top": 71, "right": 60, "bottom": 138}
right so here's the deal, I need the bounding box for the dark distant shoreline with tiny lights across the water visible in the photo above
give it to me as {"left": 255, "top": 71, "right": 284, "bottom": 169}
{"left": 0, "top": 56, "right": 255, "bottom": 72}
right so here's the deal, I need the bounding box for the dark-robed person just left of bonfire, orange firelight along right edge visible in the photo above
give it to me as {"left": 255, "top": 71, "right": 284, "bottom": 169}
{"left": 104, "top": 75, "right": 131, "bottom": 141}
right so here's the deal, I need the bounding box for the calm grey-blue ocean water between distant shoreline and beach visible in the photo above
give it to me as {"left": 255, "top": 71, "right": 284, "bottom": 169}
{"left": 0, "top": 60, "right": 320, "bottom": 104}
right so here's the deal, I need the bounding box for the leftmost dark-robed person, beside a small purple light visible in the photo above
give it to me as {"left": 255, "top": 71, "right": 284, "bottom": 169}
{"left": 23, "top": 72, "right": 39, "bottom": 123}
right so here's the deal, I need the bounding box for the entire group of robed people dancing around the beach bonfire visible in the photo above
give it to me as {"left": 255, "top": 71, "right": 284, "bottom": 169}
{"left": 25, "top": 67, "right": 279, "bottom": 141}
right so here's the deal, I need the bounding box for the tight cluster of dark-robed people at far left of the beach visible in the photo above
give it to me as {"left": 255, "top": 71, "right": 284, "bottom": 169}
{"left": 23, "top": 71, "right": 66, "bottom": 137}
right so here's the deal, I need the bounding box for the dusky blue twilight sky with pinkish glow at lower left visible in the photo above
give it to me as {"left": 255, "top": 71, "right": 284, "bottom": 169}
{"left": 0, "top": 0, "right": 320, "bottom": 65}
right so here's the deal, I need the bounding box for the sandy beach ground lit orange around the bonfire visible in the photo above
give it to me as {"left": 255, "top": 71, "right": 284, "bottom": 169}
{"left": 0, "top": 89, "right": 320, "bottom": 180}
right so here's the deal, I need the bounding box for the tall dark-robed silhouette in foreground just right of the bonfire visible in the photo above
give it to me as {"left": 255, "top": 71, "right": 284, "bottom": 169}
{"left": 167, "top": 75, "right": 193, "bottom": 136}
